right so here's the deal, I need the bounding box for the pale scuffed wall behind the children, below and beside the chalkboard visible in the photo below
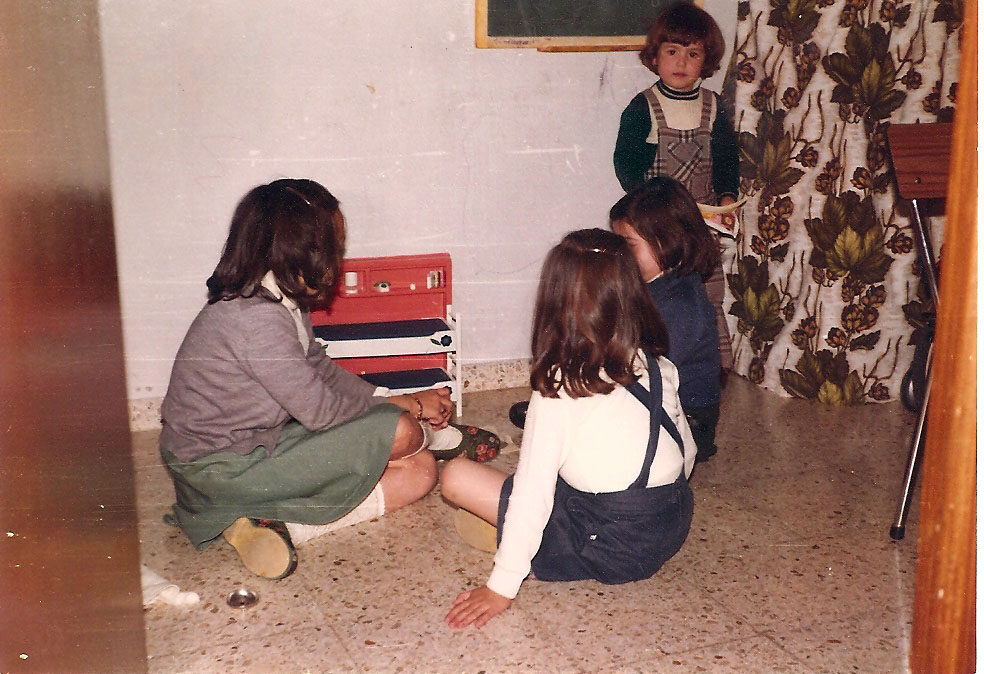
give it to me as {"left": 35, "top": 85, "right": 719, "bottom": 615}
{"left": 100, "top": 0, "right": 735, "bottom": 399}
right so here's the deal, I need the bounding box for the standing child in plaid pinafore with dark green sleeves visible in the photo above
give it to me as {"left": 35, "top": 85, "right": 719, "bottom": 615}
{"left": 614, "top": 2, "right": 739, "bottom": 370}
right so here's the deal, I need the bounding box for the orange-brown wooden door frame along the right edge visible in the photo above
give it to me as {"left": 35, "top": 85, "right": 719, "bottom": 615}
{"left": 910, "top": 0, "right": 978, "bottom": 674}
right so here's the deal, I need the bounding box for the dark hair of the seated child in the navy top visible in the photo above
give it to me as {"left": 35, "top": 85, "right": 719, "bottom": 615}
{"left": 608, "top": 176, "right": 721, "bottom": 280}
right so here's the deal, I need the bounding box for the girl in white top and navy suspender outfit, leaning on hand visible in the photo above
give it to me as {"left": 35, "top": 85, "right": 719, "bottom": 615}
{"left": 441, "top": 229, "right": 696, "bottom": 628}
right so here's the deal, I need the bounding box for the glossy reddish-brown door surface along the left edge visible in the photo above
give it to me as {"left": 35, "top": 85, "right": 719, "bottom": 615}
{"left": 0, "top": 0, "right": 147, "bottom": 674}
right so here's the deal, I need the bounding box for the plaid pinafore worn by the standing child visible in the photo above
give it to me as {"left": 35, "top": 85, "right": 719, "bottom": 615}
{"left": 645, "top": 88, "right": 734, "bottom": 370}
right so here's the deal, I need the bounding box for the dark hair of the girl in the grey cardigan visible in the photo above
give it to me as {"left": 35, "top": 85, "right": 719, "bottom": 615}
{"left": 205, "top": 178, "right": 345, "bottom": 309}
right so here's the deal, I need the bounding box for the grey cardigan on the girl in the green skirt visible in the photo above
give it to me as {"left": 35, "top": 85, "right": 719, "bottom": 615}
{"left": 160, "top": 295, "right": 386, "bottom": 461}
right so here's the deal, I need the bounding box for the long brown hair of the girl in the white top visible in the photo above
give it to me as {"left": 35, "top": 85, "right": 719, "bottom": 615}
{"left": 530, "top": 229, "right": 668, "bottom": 398}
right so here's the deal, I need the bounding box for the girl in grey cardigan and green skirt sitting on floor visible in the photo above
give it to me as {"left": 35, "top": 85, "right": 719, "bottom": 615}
{"left": 160, "top": 179, "right": 498, "bottom": 579}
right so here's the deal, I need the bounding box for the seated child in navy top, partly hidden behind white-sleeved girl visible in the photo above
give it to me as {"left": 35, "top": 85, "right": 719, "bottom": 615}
{"left": 609, "top": 177, "right": 721, "bottom": 462}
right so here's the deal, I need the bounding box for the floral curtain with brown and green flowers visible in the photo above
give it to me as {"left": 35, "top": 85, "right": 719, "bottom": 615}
{"left": 725, "top": 0, "right": 960, "bottom": 404}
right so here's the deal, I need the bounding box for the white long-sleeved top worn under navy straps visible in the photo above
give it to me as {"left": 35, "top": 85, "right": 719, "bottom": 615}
{"left": 486, "top": 358, "right": 697, "bottom": 599}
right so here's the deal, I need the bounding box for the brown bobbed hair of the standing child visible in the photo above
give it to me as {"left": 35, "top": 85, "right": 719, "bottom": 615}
{"left": 639, "top": 2, "right": 725, "bottom": 78}
